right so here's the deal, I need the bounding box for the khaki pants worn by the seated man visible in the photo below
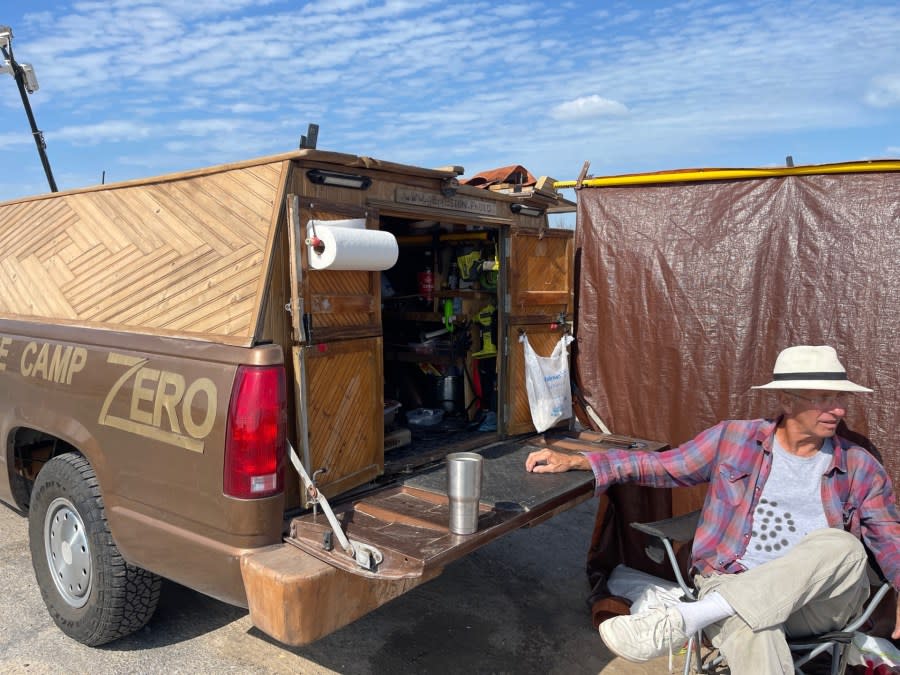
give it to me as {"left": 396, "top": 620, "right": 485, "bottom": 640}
{"left": 694, "top": 528, "right": 869, "bottom": 675}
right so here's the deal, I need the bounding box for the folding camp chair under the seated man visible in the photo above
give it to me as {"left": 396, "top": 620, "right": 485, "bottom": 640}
{"left": 631, "top": 510, "right": 890, "bottom": 675}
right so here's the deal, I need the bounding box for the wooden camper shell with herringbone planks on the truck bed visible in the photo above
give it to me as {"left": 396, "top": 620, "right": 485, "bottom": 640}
{"left": 0, "top": 149, "right": 574, "bottom": 501}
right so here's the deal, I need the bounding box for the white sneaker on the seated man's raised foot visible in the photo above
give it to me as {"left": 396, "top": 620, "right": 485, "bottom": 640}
{"left": 600, "top": 607, "right": 688, "bottom": 663}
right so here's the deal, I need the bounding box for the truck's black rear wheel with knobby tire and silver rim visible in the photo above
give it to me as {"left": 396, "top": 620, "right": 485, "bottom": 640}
{"left": 28, "top": 453, "right": 162, "bottom": 647}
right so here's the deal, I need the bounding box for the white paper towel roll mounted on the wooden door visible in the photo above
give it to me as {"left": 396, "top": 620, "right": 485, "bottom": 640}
{"left": 308, "top": 225, "right": 400, "bottom": 272}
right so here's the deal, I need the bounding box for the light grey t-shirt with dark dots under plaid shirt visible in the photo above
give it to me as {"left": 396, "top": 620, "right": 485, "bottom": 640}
{"left": 738, "top": 438, "right": 834, "bottom": 569}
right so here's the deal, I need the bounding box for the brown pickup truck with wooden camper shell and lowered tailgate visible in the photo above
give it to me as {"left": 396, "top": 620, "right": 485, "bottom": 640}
{"left": 0, "top": 149, "right": 614, "bottom": 645}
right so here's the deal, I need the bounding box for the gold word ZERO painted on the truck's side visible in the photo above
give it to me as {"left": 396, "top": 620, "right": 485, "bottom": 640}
{"left": 97, "top": 352, "right": 218, "bottom": 452}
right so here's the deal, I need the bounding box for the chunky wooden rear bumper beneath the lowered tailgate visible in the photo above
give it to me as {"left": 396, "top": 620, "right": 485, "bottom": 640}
{"left": 241, "top": 544, "right": 441, "bottom": 646}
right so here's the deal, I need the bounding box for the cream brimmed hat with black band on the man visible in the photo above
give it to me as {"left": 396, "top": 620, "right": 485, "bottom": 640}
{"left": 751, "top": 345, "right": 872, "bottom": 392}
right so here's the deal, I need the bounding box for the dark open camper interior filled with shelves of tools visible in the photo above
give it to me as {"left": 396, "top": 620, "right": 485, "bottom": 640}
{"left": 379, "top": 216, "right": 501, "bottom": 464}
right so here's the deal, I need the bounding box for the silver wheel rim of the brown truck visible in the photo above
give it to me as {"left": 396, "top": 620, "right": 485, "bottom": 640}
{"left": 44, "top": 497, "right": 93, "bottom": 608}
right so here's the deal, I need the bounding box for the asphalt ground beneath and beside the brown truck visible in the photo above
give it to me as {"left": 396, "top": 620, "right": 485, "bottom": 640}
{"left": 0, "top": 500, "right": 680, "bottom": 675}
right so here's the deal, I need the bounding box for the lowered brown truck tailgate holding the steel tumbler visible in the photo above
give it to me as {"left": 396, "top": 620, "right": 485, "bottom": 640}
{"left": 285, "top": 433, "right": 631, "bottom": 579}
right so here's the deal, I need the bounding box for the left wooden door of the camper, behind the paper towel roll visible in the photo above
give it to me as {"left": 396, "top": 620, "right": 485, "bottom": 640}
{"left": 289, "top": 196, "right": 384, "bottom": 496}
